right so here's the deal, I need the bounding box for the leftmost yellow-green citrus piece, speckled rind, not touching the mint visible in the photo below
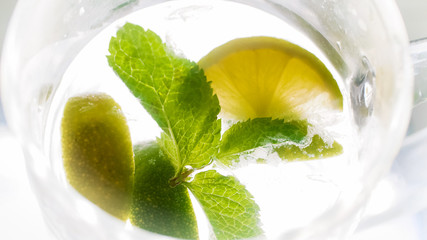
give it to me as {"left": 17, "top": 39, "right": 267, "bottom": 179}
{"left": 61, "top": 94, "right": 134, "bottom": 220}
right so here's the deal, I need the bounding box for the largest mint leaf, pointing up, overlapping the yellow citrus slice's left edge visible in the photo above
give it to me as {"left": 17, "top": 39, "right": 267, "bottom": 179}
{"left": 107, "top": 23, "right": 221, "bottom": 174}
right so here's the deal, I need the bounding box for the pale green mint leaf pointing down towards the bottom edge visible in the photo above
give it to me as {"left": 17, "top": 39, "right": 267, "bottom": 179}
{"left": 184, "top": 170, "right": 262, "bottom": 240}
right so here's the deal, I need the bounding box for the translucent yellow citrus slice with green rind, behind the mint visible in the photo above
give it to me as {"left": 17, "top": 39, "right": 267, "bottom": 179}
{"left": 199, "top": 37, "right": 343, "bottom": 120}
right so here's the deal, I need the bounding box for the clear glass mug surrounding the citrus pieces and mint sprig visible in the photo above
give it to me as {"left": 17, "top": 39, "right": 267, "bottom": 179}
{"left": 1, "top": 0, "right": 422, "bottom": 240}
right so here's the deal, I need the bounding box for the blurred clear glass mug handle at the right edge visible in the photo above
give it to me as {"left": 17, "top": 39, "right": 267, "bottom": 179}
{"left": 357, "top": 38, "right": 427, "bottom": 232}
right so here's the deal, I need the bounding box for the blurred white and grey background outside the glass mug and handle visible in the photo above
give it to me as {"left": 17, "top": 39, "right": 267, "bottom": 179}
{"left": 0, "top": 0, "right": 427, "bottom": 240}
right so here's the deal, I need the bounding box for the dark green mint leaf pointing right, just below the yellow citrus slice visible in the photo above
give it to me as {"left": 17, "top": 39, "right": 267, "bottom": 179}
{"left": 217, "top": 118, "right": 308, "bottom": 165}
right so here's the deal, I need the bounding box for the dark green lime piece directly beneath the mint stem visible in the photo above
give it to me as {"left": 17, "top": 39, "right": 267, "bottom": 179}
{"left": 130, "top": 143, "right": 198, "bottom": 239}
